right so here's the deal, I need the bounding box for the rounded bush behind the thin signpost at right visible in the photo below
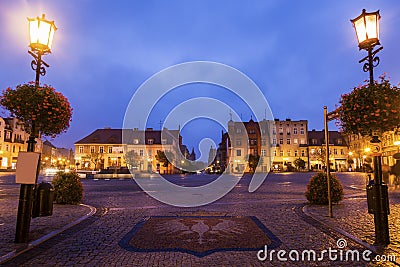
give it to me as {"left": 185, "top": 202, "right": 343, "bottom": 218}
{"left": 305, "top": 172, "right": 343, "bottom": 205}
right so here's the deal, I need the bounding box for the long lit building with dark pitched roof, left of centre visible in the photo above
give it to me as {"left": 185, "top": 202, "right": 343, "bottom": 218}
{"left": 75, "top": 128, "right": 188, "bottom": 173}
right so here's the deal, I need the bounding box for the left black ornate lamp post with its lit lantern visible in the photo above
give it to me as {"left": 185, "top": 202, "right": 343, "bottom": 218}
{"left": 15, "top": 14, "right": 57, "bottom": 243}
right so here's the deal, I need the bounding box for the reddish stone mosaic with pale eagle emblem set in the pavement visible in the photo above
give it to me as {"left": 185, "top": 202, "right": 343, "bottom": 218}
{"left": 119, "top": 216, "right": 281, "bottom": 257}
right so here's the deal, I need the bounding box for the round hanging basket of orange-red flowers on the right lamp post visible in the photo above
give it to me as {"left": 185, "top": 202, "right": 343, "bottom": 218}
{"left": 338, "top": 76, "right": 400, "bottom": 136}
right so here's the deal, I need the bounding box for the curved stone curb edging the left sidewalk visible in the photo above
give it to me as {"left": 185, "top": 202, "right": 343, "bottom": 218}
{"left": 0, "top": 204, "right": 97, "bottom": 265}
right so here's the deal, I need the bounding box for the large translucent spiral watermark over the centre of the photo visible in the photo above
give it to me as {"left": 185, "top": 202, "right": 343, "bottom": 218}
{"left": 122, "top": 61, "right": 274, "bottom": 207}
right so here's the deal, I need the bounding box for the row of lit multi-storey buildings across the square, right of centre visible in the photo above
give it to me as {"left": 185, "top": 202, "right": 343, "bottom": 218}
{"left": 214, "top": 119, "right": 348, "bottom": 172}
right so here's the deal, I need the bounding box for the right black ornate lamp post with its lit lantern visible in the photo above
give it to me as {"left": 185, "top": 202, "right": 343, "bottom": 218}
{"left": 351, "top": 9, "right": 390, "bottom": 246}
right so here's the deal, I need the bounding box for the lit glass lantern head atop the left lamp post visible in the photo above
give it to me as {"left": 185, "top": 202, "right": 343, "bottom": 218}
{"left": 28, "top": 14, "right": 57, "bottom": 54}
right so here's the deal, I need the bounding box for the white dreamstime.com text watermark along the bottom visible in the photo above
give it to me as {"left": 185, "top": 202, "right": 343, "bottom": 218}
{"left": 257, "top": 238, "right": 396, "bottom": 262}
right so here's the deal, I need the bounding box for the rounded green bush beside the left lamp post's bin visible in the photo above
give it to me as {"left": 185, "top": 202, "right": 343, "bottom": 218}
{"left": 52, "top": 172, "right": 83, "bottom": 204}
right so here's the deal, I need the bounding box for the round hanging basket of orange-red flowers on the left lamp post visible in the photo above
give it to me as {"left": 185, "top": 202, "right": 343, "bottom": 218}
{"left": 0, "top": 83, "right": 72, "bottom": 137}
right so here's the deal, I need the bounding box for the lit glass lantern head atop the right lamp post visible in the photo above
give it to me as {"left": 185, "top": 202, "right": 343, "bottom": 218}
{"left": 351, "top": 9, "right": 381, "bottom": 49}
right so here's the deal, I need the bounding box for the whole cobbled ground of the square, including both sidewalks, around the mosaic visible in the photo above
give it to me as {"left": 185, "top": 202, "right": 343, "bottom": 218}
{"left": 0, "top": 175, "right": 400, "bottom": 266}
